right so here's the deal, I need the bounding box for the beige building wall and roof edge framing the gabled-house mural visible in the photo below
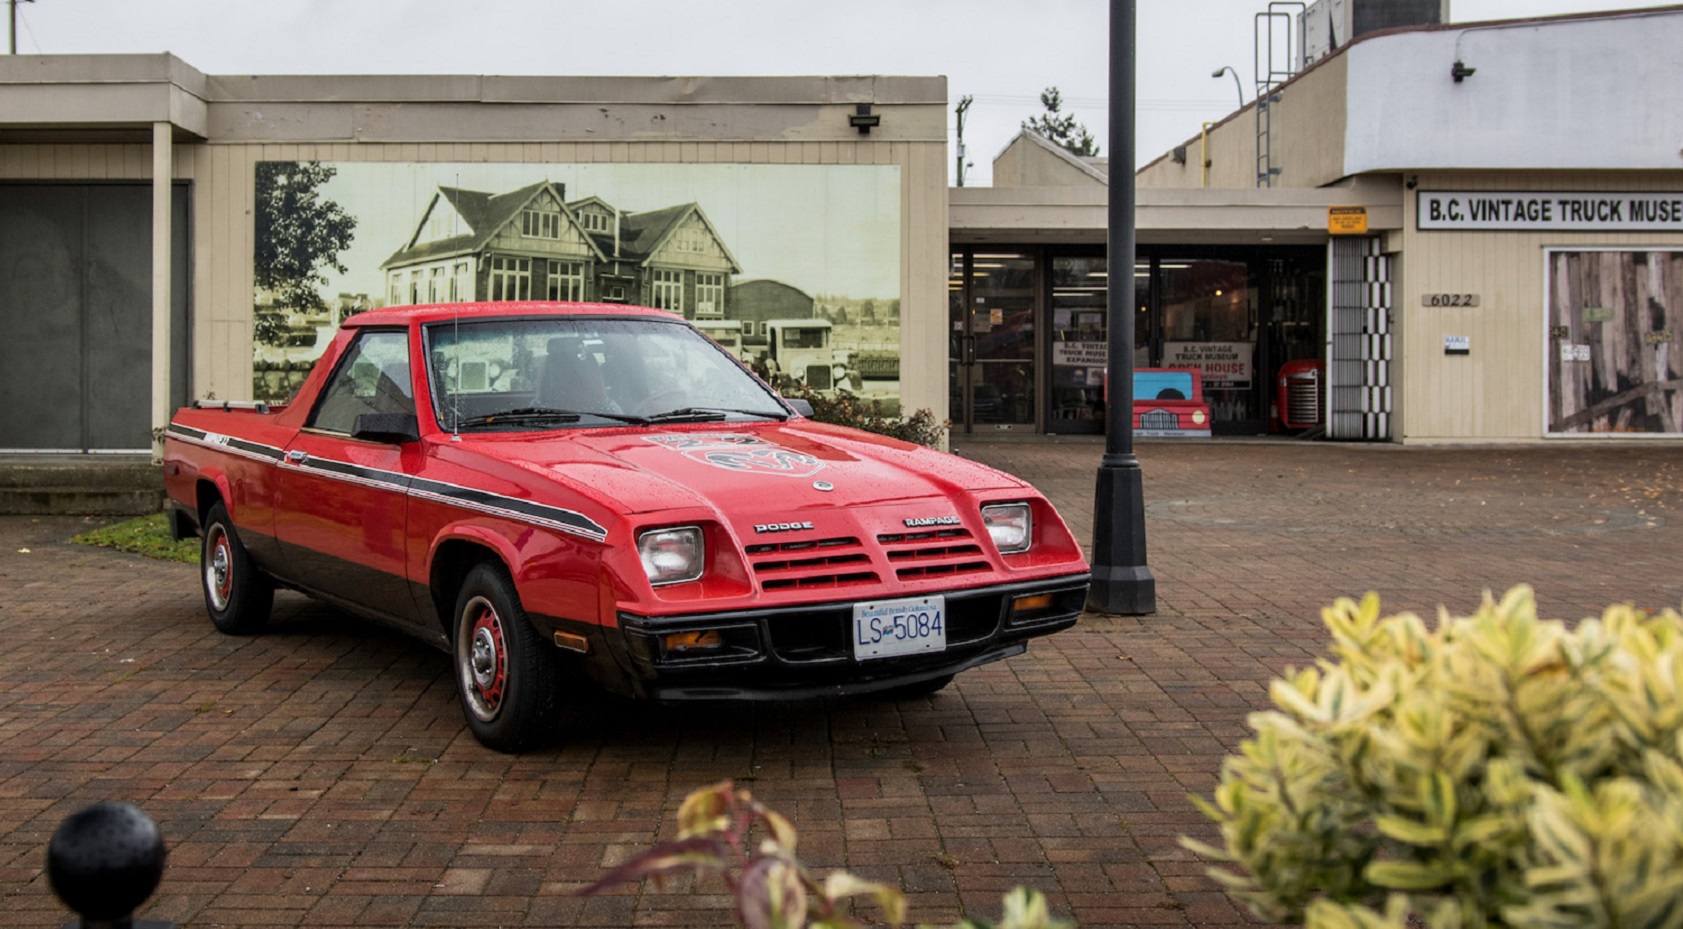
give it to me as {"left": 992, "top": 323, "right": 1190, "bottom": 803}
{"left": 0, "top": 63, "right": 948, "bottom": 425}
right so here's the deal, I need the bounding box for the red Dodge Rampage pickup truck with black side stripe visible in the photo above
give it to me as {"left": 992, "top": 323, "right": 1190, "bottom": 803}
{"left": 163, "top": 303, "right": 1089, "bottom": 751}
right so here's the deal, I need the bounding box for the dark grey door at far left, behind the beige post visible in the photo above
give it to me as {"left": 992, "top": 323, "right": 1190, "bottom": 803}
{"left": 0, "top": 183, "right": 188, "bottom": 453}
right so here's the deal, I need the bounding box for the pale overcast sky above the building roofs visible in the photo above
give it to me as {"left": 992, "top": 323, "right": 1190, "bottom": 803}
{"left": 0, "top": 0, "right": 1676, "bottom": 185}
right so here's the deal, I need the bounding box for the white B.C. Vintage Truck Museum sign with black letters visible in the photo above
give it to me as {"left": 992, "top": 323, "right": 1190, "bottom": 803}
{"left": 1414, "top": 190, "right": 1683, "bottom": 232}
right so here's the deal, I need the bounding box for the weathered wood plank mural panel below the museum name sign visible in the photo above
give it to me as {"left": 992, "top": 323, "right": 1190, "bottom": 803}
{"left": 1547, "top": 249, "right": 1683, "bottom": 434}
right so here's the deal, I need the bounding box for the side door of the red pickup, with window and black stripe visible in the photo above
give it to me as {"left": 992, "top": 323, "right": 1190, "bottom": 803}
{"left": 274, "top": 330, "right": 421, "bottom": 623}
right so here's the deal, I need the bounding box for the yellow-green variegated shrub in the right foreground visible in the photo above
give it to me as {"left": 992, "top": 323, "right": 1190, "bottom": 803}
{"left": 1181, "top": 587, "right": 1683, "bottom": 929}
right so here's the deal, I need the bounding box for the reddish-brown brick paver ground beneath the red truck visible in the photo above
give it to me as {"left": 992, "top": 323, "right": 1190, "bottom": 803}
{"left": 0, "top": 439, "right": 1683, "bottom": 927}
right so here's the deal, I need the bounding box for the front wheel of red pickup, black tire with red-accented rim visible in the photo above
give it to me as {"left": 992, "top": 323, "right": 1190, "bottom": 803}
{"left": 451, "top": 562, "right": 560, "bottom": 752}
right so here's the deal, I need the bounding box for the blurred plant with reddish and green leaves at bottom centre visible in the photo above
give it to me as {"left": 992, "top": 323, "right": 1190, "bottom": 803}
{"left": 579, "top": 781, "right": 1070, "bottom": 929}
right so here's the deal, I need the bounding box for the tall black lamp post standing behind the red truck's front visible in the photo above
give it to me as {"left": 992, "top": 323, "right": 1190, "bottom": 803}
{"left": 1087, "top": 0, "right": 1156, "bottom": 616}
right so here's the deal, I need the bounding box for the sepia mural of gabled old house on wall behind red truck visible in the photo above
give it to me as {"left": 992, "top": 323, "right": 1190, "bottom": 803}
{"left": 252, "top": 162, "right": 900, "bottom": 409}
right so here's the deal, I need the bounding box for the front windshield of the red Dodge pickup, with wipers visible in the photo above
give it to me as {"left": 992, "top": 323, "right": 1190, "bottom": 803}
{"left": 426, "top": 316, "right": 788, "bottom": 431}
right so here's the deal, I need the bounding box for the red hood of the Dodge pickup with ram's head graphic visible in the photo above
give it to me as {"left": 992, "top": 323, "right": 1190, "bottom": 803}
{"left": 476, "top": 421, "right": 1027, "bottom": 515}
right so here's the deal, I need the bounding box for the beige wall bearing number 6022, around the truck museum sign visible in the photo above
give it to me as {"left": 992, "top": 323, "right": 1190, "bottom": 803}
{"left": 1387, "top": 172, "right": 1683, "bottom": 443}
